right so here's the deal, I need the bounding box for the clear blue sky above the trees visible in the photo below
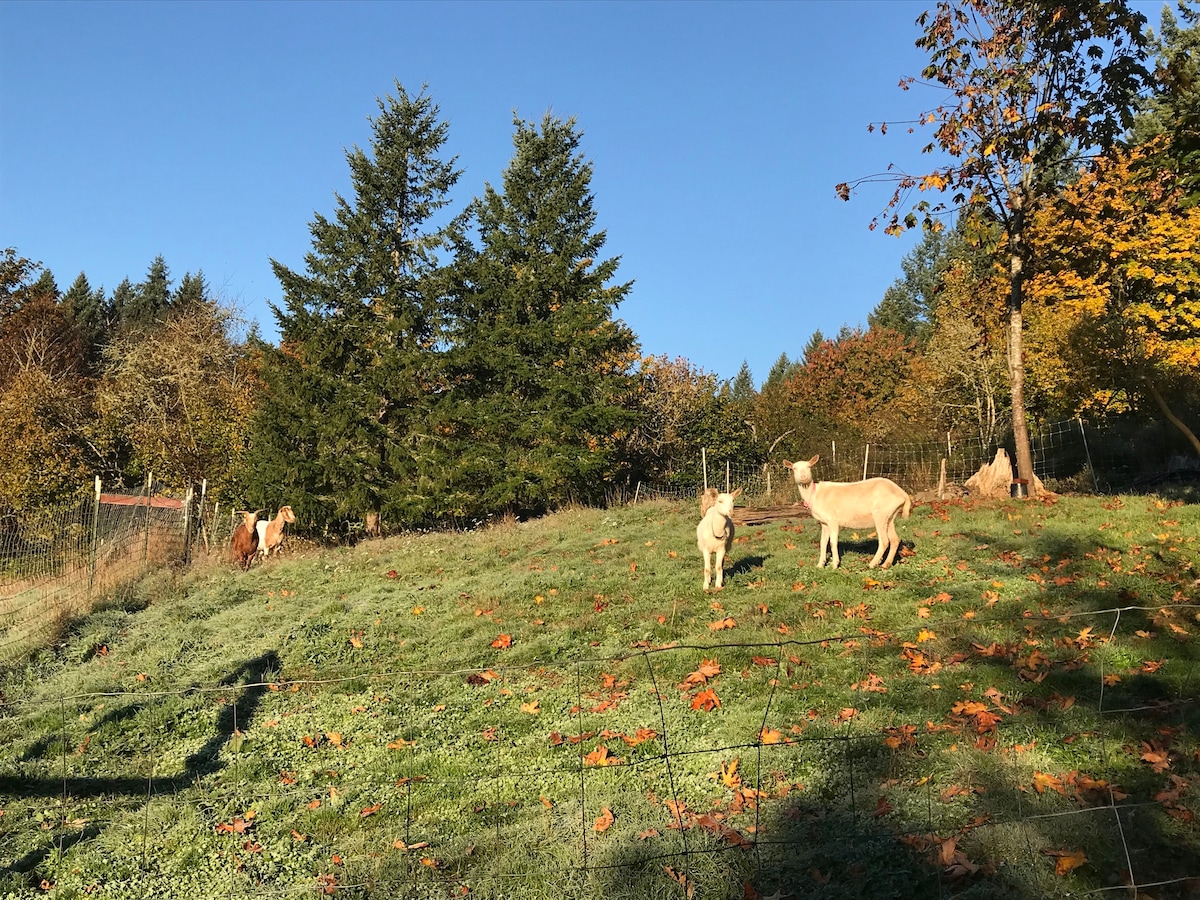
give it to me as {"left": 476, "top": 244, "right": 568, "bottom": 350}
{"left": 0, "top": 0, "right": 1162, "bottom": 383}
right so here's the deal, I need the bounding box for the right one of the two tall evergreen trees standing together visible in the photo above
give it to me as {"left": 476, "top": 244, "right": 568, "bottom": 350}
{"left": 442, "top": 113, "right": 637, "bottom": 514}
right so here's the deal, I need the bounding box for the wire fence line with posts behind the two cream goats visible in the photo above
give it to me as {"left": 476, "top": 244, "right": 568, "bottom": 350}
{"left": 635, "top": 418, "right": 1200, "bottom": 504}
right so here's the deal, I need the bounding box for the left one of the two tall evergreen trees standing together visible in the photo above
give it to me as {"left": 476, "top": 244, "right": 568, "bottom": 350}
{"left": 248, "top": 82, "right": 461, "bottom": 526}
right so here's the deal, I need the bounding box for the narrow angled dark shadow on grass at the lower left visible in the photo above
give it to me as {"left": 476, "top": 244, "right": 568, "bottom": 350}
{"left": 0, "top": 650, "right": 280, "bottom": 887}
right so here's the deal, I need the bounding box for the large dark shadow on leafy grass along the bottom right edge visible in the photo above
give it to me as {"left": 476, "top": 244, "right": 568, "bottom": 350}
{"left": 583, "top": 738, "right": 1200, "bottom": 900}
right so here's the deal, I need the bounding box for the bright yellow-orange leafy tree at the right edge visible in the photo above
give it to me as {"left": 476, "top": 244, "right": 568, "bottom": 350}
{"left": 1030, "top": 142, "right": 1200, "bottom": 455}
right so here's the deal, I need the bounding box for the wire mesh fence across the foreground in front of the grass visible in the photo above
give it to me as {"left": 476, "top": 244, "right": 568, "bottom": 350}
{"left": 0, "top": 604, "right": 1200, "bottom": 898}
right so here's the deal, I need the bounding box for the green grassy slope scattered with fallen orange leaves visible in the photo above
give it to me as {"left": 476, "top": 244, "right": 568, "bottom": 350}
{"left": 0, "top": 497, "right": 1200, "bottom": 898}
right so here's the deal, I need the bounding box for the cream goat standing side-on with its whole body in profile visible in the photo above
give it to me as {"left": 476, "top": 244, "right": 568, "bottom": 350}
{"left": 784, "top": 456, "right": 912, "bottom": 569}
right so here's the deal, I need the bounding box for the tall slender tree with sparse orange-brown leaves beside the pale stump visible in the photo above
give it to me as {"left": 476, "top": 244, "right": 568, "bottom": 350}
{"left": 836, "top": 0, "right": 1148, "bottom": 494}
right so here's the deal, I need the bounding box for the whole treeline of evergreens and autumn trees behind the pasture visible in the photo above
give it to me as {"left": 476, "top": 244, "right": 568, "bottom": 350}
{"left": 0, "top": 7, "right": 1200, "bottom": 533}
